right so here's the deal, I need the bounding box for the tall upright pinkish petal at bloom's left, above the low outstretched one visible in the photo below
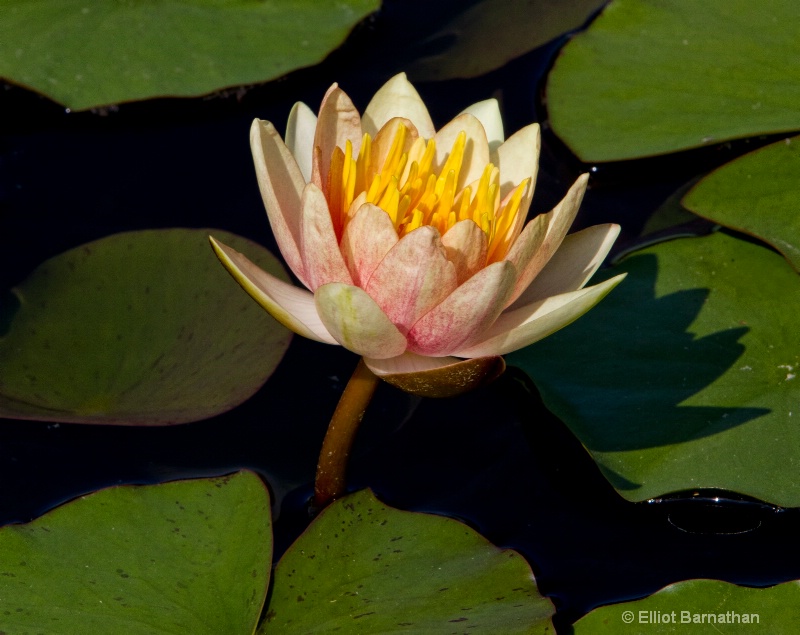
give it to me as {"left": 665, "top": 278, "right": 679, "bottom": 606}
{"left": 250, "top": 119, "right": 308, "bottom": 286}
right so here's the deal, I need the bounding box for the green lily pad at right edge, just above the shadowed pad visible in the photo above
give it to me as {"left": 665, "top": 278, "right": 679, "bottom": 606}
{"left": 682, "top": 137, "right": 800, "bottom": 271}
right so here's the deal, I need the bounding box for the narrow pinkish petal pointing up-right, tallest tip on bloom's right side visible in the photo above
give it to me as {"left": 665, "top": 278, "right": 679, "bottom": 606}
{"left": 506, "top": 174, "right": 589, "bottom": 304}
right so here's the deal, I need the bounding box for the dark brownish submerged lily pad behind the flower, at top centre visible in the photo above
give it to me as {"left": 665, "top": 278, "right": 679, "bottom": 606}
{"left": 406, "top": 0, "right": 605, "bottom": 81}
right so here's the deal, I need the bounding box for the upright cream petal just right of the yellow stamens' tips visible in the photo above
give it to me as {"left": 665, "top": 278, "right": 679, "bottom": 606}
{"left": 491, "top": 123, "right": 541, "bottom": 202}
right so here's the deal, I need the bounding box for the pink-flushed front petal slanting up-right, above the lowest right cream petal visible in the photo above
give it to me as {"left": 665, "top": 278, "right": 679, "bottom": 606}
{"left": 408, "top": 261, "right": 516, "bottom": 357}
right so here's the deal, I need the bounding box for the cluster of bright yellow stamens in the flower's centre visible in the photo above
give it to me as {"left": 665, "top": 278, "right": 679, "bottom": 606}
{"left": 328, "top": 124, "right": 529, "bottom": 264}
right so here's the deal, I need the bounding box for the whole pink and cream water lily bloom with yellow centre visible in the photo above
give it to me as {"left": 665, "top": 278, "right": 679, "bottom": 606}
{"left": 212, "top": 74, "right": 623, "bottom": 394}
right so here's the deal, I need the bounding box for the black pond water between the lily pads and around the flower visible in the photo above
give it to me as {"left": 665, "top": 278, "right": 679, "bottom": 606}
{"left": 0, "top": 0, "right": 800, "bottom": 632}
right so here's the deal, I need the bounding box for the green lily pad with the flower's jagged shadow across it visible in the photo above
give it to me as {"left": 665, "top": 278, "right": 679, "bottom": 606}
{"left": 507, "top": 233, "right": 800, "bottom": 506}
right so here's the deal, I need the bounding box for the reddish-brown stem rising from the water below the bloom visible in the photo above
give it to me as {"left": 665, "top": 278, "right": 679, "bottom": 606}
{"left": 314, "top": 359, "right": 379, "bottom": 510}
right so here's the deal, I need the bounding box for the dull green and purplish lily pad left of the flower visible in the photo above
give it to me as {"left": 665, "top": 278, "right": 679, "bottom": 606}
{"left": 0, "top": 229, "right": 291, "bottom": 425}
